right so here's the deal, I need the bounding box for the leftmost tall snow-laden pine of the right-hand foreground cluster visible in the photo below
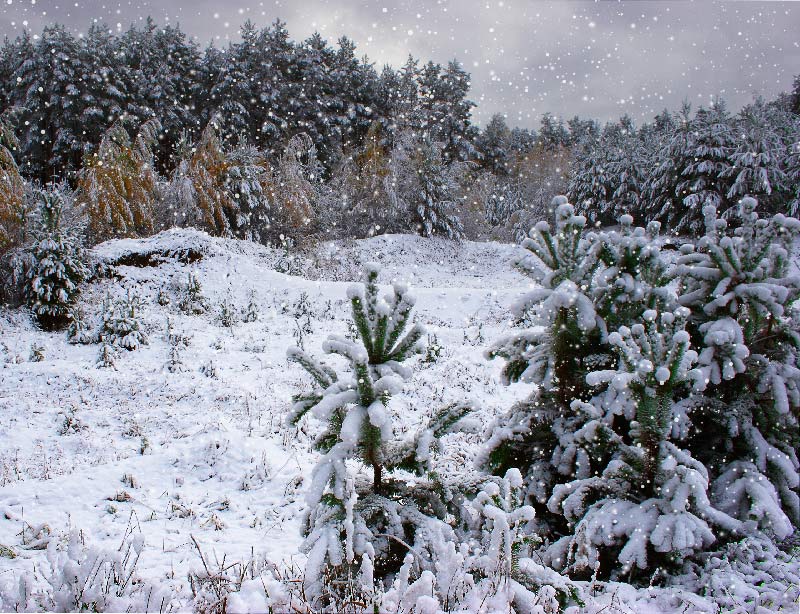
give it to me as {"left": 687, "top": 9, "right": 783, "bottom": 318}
{"left": 482, "top": 197, "right": 677, "bottom": 531}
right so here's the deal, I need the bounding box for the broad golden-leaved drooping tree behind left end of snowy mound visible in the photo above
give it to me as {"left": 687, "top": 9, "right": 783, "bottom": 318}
{"left": 78, "top": 119, "right": 161, "bottom": 241}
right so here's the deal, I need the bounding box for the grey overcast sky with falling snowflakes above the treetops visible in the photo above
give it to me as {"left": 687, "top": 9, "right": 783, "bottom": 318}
{"left": 0, "top": 0, "right": 800, "bottom": 127}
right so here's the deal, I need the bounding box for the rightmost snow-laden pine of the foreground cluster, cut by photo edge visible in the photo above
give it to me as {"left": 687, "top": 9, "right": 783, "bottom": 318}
{"left": 677, "top": 197, "right": 800, "bottom": 539}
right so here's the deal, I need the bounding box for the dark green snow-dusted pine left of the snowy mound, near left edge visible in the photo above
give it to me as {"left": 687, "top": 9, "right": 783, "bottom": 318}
{"left": 24, "top": 185, "right": 89, "bottom": 330}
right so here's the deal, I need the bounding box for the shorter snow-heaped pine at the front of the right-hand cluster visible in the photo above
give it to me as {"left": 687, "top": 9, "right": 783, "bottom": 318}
{"left": 545, "top": 307, "right": 742, "bottom": 578}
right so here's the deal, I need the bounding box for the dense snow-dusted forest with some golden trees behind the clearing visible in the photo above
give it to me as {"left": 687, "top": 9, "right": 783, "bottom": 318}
{"left": 0, "top": 20, "right": 800, "bottom": 258}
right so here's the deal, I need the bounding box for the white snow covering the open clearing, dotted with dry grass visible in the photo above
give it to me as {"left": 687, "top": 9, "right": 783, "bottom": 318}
{"left": 0, "top": 230, "right": 530, "bottom": 603}
